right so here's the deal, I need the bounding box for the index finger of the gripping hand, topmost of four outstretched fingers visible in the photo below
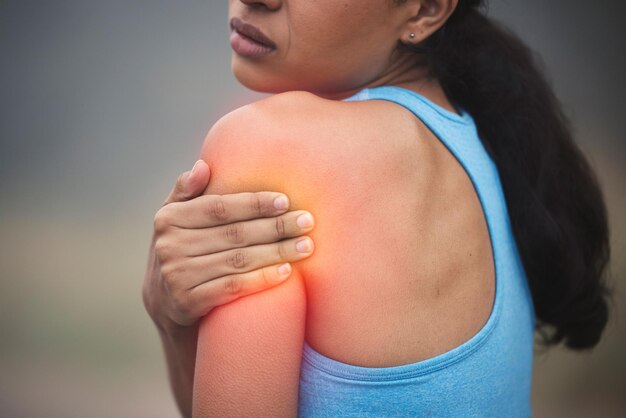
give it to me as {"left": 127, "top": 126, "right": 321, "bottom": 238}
{"left": 169, "top": 192, "right": 289, "bottom": 229}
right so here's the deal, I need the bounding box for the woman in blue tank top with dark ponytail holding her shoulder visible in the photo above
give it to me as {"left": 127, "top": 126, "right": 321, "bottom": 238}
{"left": 144, "top": 0, "right": 609, "bottom": 417}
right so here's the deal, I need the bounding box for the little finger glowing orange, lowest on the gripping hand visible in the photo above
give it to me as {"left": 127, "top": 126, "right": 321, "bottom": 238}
{"left": 190, "top": 263, "right": 292, "bottom": 316}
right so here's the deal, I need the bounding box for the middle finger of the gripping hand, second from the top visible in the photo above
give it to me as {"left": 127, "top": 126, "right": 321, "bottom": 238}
{"left": 172, "top": 210, "right": 315, "bottom": 257}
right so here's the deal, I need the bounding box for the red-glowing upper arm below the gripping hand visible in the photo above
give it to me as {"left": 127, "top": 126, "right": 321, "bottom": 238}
{"left": 193, "top": 269, "right": 306, "bottom": 417}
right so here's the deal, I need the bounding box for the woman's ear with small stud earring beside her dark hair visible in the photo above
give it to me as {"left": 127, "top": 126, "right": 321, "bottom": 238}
{"left": 400, "top": 0, "right": 458, "bottom": 45}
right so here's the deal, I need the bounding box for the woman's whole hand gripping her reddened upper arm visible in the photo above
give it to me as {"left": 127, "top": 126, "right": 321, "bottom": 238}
{"left": 143, "top": 160, "right": 313, "bottom": 330}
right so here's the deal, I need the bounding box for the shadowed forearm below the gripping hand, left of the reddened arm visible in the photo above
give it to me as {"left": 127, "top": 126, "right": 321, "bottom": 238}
{"left": 159, "top": 325, "right": 198, "bottom": 418}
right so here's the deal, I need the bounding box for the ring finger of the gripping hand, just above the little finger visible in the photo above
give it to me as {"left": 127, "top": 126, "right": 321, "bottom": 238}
{"left": 185, "top": 236, "right": 314, "bottom": 289}
